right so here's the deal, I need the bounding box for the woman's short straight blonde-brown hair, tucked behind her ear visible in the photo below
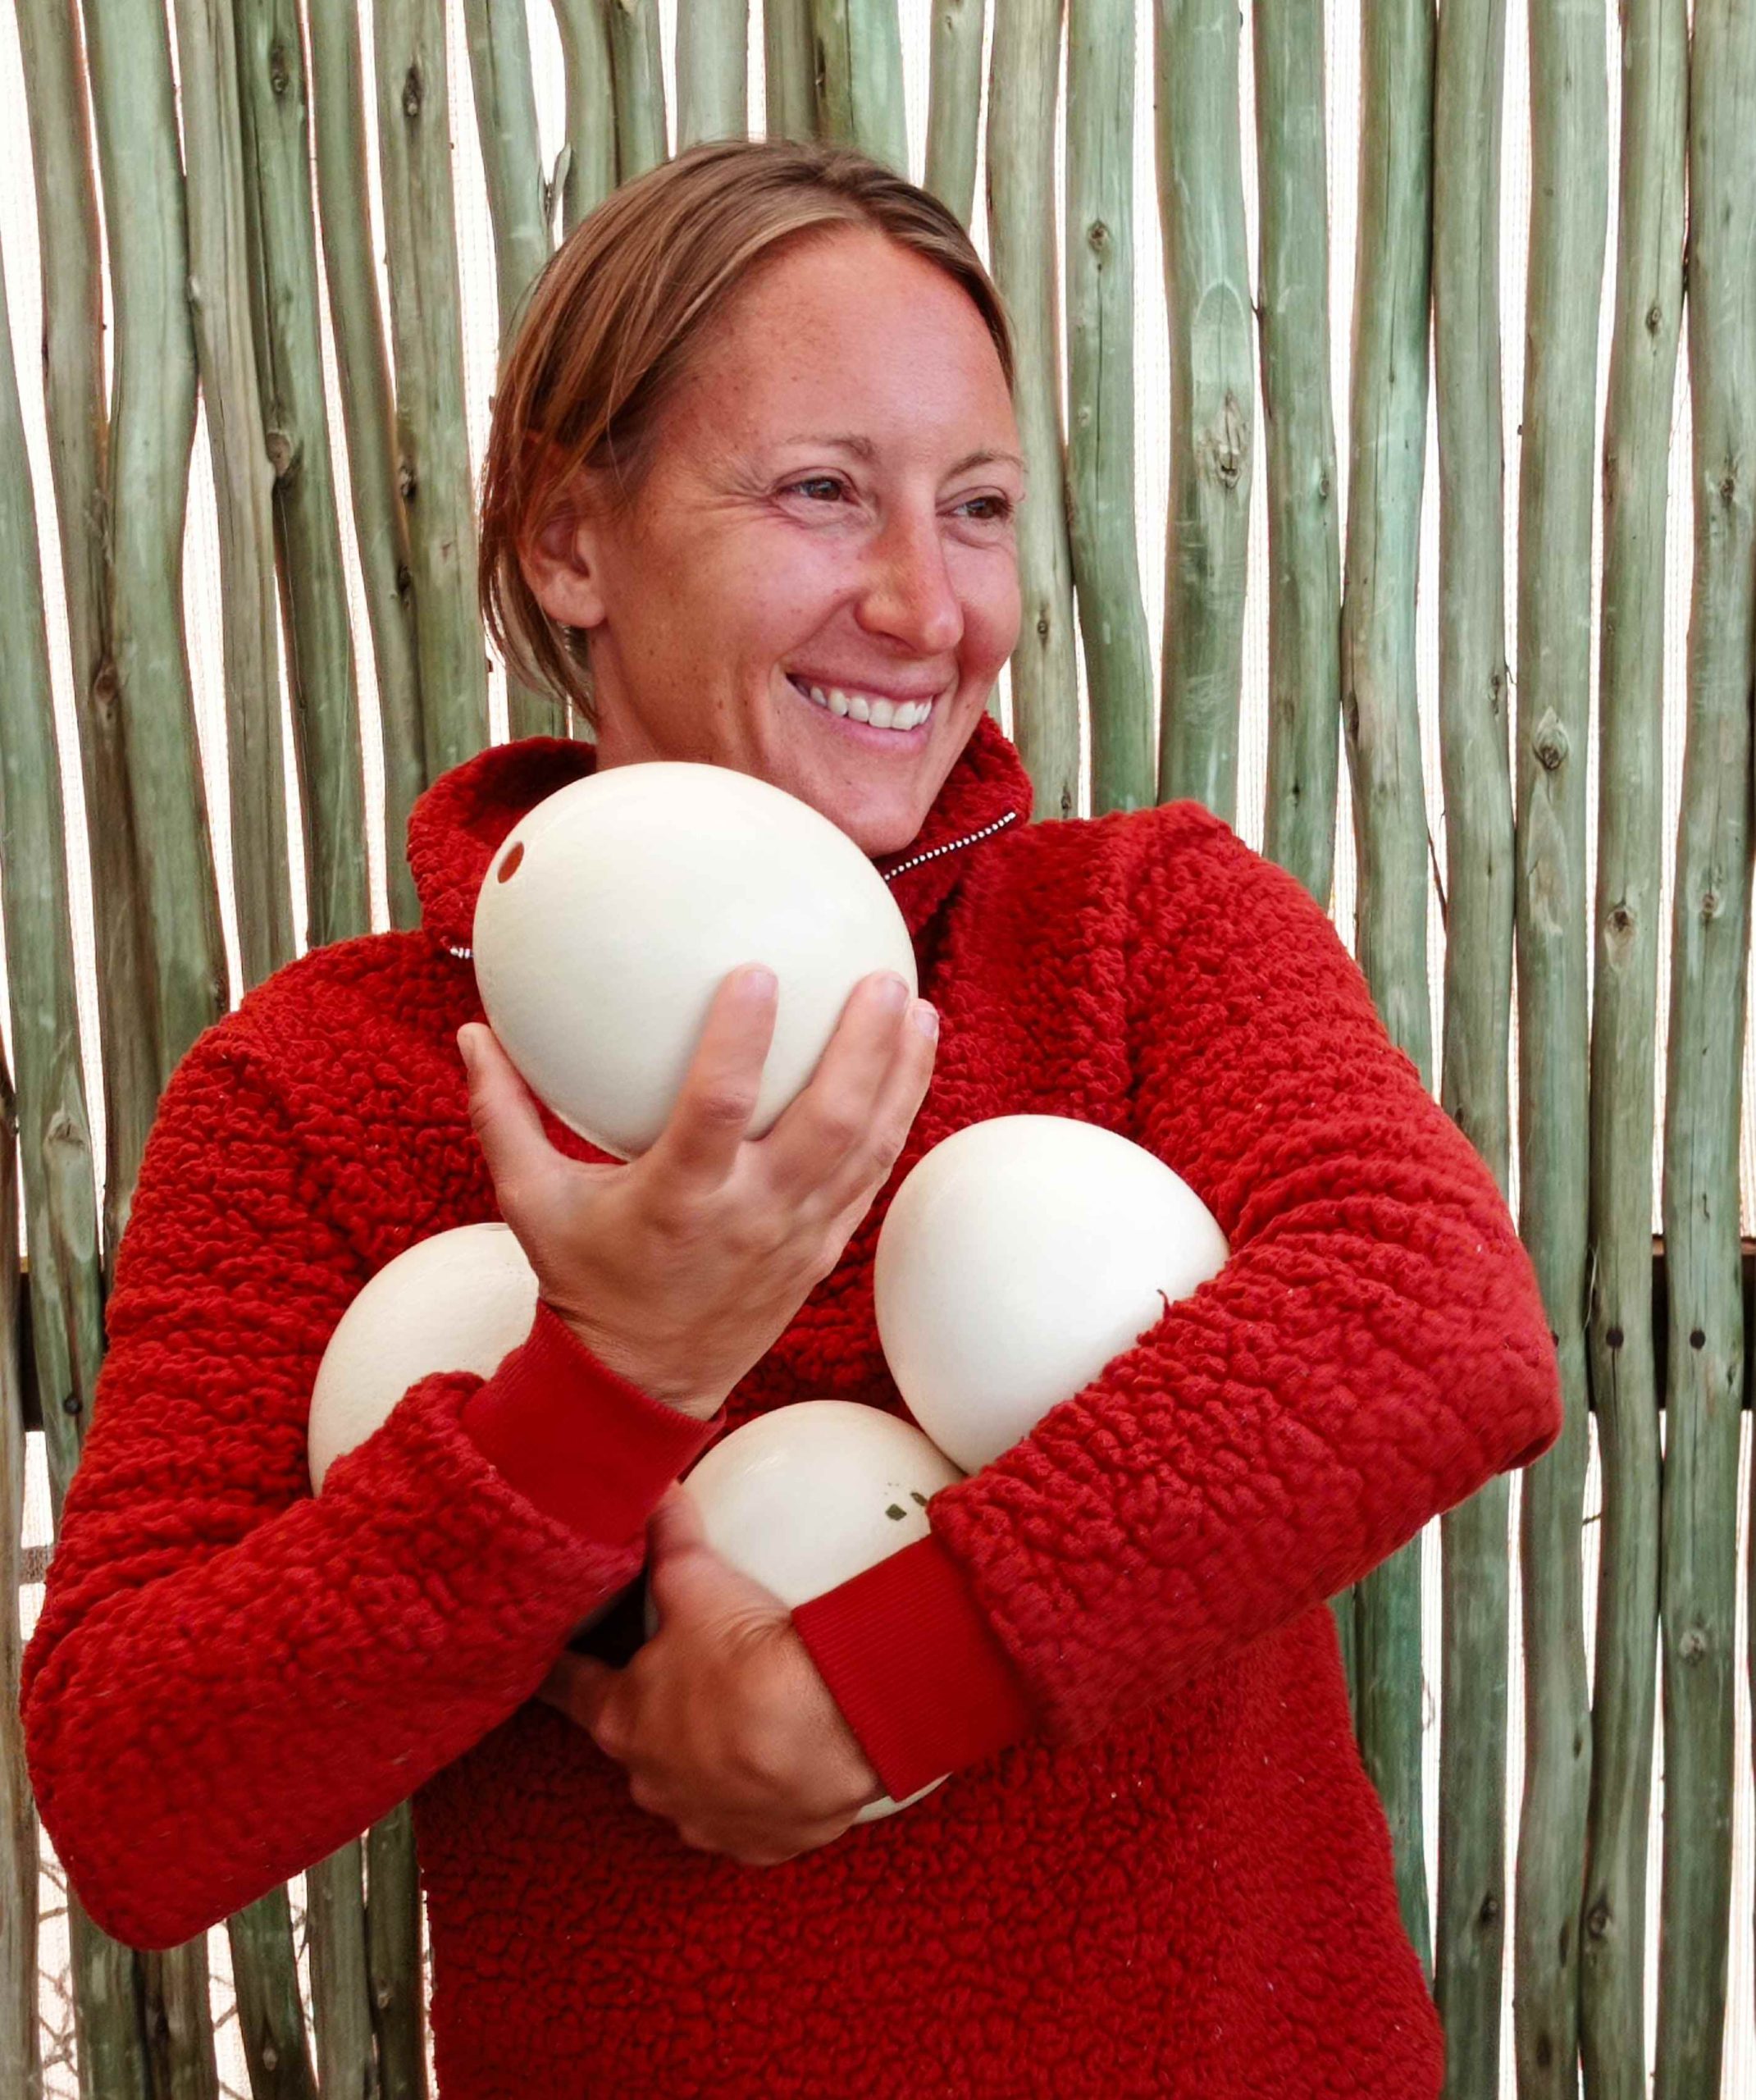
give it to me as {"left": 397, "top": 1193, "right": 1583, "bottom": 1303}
{"left": 477, "top": 139, "right": 1015, "bottom": 723}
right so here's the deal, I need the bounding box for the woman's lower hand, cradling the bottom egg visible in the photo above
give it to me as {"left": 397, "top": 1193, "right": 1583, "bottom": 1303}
{"left": 540, "top": 1486, "right": 884, "bottom": 1867}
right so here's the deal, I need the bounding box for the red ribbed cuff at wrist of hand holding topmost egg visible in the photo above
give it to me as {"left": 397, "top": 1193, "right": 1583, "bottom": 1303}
{"left": 460, "top": 1302, "right": 725, "bottom": 1545}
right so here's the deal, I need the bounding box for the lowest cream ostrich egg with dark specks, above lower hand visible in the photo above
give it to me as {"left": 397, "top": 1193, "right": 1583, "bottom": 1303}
{"left": 647, "top": 1401, "right": 962, "bottom": 1823}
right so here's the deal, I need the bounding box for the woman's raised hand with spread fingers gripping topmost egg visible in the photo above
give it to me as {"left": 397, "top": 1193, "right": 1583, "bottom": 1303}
{"left": 458, "top": 966, "right": 937, "bottom": 1420}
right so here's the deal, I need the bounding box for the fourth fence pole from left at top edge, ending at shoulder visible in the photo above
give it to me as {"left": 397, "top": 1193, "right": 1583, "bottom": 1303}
{"left": 233, "top": 0, "right": 370, "bottom": 947}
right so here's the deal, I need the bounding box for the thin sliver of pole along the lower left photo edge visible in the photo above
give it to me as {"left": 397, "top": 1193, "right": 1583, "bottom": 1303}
{"left": 0, "top": 1054, "right": 42, "bottom": 2100}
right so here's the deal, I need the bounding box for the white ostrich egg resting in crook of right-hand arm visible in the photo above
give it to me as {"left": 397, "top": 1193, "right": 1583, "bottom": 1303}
{"left": 873, "top": 1115, "right": 1227, "bottom": 1472}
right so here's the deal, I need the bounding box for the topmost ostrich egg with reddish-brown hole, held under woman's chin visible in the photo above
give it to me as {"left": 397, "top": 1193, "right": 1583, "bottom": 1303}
{"left": 472, "top": 760, "right": 916, "bottom": 1159}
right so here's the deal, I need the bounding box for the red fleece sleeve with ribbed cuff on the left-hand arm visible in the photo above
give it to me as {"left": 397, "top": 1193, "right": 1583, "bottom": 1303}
{"left": 23, "top": 1008, "right": 714, "bottom": 1947}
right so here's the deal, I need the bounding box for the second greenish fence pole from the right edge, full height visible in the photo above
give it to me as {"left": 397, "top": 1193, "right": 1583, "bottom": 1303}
{"left": 1580, "top": 0, "right": 1689, "bottom": 2100}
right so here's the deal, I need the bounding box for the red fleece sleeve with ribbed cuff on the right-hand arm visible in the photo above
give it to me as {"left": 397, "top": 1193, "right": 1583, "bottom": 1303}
{"left": 794, "top": 804, "right": 1562, "bottom": 1800}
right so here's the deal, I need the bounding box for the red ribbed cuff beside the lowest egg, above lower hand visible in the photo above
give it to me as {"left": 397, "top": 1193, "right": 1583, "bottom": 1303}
{"left": 791, "top": 1535, "right": 1031, "bottom": 1801}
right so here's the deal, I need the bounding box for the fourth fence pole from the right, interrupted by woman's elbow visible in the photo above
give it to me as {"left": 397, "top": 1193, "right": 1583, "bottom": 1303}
{"left": 1433, "top": 0, "right": 1512, "bottom": 2100}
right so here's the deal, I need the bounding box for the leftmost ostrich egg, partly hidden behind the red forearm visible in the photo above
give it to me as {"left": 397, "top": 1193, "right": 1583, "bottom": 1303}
{"left": 307, "top": 1224, "right": 536, "bottom": 1489}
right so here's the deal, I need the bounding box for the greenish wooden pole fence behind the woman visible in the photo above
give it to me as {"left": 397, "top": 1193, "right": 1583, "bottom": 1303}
{"left": 0, "top": 0, "right": 1756, "bottom": 2100}
